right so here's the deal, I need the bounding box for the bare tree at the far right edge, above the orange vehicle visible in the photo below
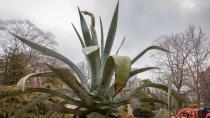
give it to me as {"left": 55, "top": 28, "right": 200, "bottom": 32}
{"left": 185, "top": 25, "right": 210, "bottom": 104}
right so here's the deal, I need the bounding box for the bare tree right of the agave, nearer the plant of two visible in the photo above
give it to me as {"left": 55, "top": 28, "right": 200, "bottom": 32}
{"left": 154, "top": 33, "right": 191, "bottom": 93}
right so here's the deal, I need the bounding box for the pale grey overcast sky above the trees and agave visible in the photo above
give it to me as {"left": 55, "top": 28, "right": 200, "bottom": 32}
{"left": 0, "top": 0, "right": 210, "bottom": 78}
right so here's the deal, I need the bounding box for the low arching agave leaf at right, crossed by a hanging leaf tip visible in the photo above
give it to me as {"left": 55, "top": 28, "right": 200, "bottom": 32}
{"left": 135, "top": 82, "right": 185, "bottom": 105}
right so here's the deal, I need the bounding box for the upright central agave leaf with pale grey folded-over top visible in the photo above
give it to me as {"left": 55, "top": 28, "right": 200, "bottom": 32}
{"left": 83, "top": 46, "right": 101, "bottom": 90}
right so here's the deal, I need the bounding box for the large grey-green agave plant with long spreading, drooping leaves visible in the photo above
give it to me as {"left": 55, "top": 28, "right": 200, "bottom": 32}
{"left": 1, "top": 1, "right": 183, "bottom": 117}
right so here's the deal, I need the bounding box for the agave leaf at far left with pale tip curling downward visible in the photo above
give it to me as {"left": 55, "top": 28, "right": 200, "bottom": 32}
{"left": 17, "top": 71, "right": 55, "bottom": 91}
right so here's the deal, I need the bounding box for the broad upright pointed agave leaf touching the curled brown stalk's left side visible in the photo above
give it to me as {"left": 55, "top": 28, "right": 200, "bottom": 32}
{"left": 78, "top": 8, "right": 93, "bottom": 46}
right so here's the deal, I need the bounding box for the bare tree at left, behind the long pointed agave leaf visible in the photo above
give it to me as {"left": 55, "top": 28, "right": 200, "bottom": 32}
{"left": 0, "top": 19, "right": 56, "bottom": 84}
